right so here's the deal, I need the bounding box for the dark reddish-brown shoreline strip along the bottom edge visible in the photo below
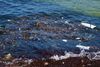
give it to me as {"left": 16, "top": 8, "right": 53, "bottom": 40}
{"left": 0, "top": 57, "right": 100, "bottom": 67}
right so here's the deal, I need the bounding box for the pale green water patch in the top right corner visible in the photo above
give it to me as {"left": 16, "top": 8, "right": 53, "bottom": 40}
{"left": 33, "top": 0, "right": 100, "bottom": 17}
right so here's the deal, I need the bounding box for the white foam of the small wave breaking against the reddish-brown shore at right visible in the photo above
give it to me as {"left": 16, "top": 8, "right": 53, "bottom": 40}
{"left": 50, "top": 50, "right": 100, "bottom": 61}
